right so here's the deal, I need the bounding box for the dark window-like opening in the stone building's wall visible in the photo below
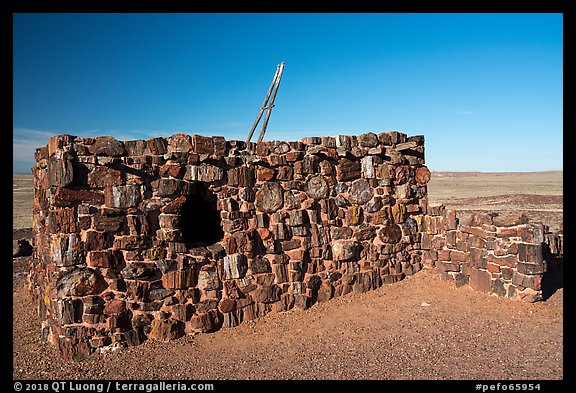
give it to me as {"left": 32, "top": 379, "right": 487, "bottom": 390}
{"left": 180, "top": 182, "right": 224, "bottom": 248}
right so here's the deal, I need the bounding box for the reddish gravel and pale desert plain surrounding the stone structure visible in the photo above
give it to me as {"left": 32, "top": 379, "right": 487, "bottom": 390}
{"left": 12, "top": 171, "right": 564, "bottom": 380}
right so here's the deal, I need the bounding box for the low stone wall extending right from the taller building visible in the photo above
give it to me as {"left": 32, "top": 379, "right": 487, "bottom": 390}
{"left": 421, "top": 205, "right": 564, "bottom": 302}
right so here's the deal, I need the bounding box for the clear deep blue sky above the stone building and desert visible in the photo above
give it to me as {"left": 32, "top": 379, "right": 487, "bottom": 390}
{"left": 13, "top": 13, "right": 563, "bottom": 173}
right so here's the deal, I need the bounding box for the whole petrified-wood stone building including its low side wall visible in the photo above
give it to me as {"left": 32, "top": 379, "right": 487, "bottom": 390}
{"left": 29, "top": 131, "right": 561, "bottom": 359}
